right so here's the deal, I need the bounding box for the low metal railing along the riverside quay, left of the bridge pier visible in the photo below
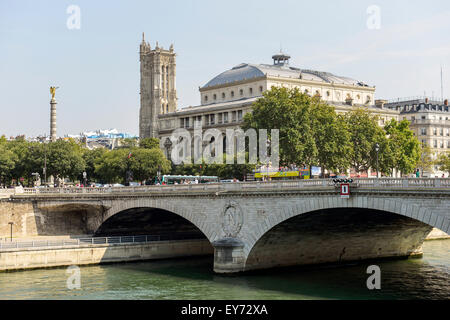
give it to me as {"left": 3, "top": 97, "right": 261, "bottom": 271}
{"left": 0, "top": 233, "right": 201, "bottom": 251}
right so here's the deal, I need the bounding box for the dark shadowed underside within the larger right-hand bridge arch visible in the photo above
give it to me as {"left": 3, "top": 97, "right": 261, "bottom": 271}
{"left": 244, "top": 207, "right": 432, "bottom": 271}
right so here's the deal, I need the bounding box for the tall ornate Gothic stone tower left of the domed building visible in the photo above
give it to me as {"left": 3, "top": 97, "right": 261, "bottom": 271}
{"left": 139, "top": 34, "right": 177, "bottom": 138}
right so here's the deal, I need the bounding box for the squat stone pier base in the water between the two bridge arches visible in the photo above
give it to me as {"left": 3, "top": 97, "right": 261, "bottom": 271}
{"left": 212, "top": 238, "right": 246, "bottom": 273}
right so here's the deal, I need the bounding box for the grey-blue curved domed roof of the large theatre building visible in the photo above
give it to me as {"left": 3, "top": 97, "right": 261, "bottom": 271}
{"left": 203, "top": 63, "right": 368, "bottom": 89}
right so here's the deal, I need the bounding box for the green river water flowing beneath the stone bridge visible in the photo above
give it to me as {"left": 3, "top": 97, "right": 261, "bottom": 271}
{"left": 0, "top": 240, "right": 450, "bottom": 300}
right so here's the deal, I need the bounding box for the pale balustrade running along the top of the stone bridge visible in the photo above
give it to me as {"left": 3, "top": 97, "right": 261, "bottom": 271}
{"left": 15, "top": 178, "right": 450, "bottom": 195}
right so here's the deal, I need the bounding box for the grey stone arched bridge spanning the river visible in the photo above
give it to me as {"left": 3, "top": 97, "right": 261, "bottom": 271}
{"left": 0, "top": 178, "right": 450, "bottom": 273}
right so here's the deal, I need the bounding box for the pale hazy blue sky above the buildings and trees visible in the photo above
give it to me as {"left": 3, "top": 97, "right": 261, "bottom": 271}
{"left": 0, "top": 0, "right": 450, "bottom": 136}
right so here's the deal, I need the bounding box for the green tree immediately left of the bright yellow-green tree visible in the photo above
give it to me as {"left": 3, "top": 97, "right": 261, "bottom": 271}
{"left": 345, "top": 108, "right": 392, "bottom": 173}
